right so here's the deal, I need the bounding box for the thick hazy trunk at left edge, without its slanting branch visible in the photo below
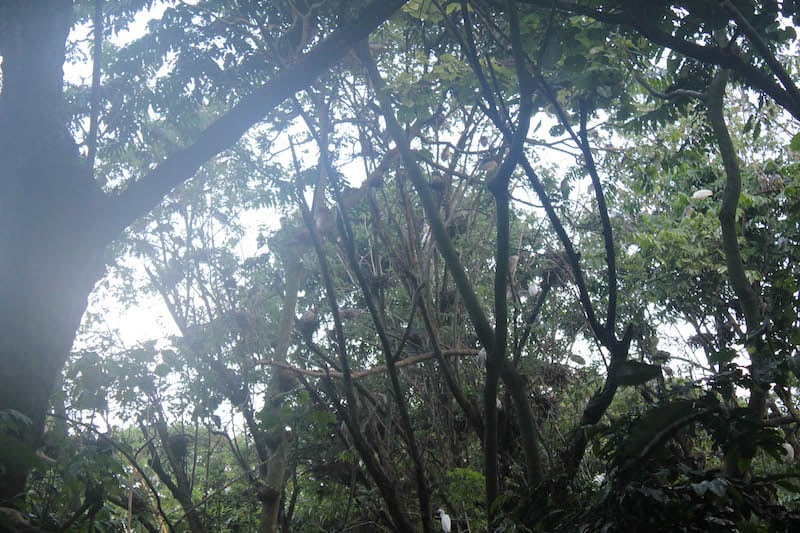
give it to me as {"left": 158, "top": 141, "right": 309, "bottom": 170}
{"left": 0, "top": 1, "right": 108, "bottom": 502}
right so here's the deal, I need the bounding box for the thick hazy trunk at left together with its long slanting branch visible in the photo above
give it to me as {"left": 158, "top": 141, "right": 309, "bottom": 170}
{"left": 0, "top": 0, "right": 403, "bottom": 502}
